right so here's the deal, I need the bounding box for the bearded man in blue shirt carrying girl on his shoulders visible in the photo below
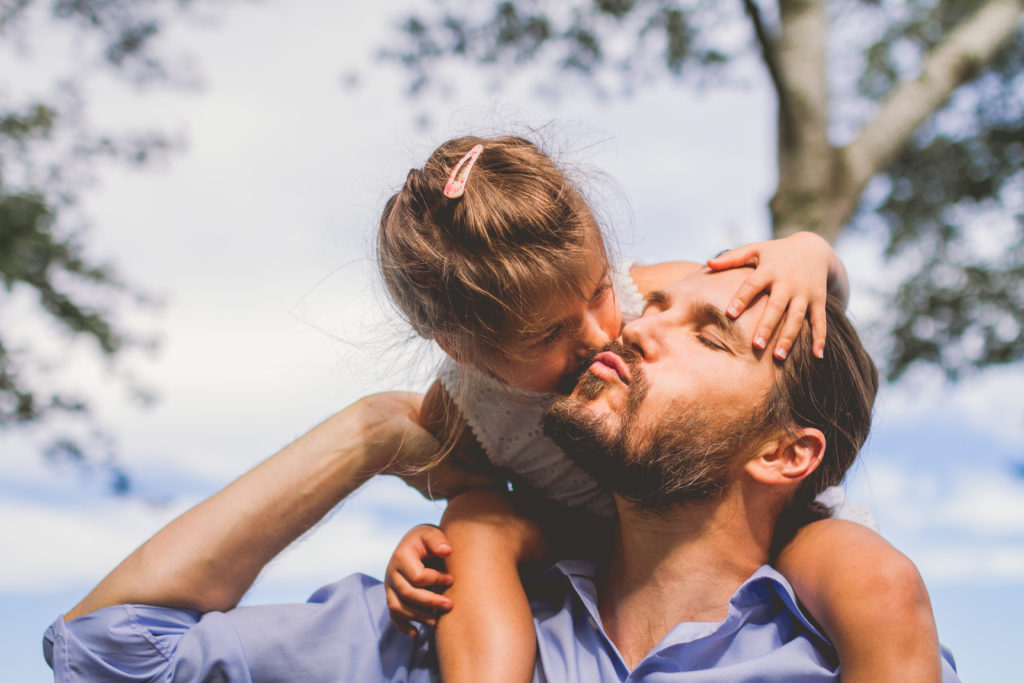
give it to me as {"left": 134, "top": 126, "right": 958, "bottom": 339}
{"left": 44, "top": 271, "right": 955, "bottom": 681}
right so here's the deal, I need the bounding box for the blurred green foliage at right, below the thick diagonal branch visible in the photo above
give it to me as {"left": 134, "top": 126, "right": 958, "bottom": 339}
{"left": 870, "top": 14, "right": 1024, "bottom": 380}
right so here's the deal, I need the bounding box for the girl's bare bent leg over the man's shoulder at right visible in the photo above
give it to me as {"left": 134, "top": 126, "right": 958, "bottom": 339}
{"left": 776, "top": 519, "right": 942, "bottom": 683}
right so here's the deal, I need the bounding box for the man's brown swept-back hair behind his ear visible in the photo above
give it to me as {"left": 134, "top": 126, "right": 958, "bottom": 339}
{"left": 765, "top": 297, "right": 879, "bottom": 547}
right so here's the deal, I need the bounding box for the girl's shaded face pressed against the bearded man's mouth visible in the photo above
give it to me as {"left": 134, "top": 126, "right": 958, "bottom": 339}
{"left": 479, "top": 249, "right": 623, "bottom": 392}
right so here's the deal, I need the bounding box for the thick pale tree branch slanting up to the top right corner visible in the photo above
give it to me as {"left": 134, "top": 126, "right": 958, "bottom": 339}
{"left": 843, "top": 0, "right": 1024, "bottom": 196}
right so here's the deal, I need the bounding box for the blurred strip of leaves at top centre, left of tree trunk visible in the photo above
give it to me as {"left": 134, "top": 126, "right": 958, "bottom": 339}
{"left": 380, "top": 0, "right": 731, "bottom": 95}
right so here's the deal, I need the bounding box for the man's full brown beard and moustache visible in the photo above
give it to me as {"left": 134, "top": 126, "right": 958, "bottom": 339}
{"left": 544, "top": 342, "right": 767, "bottom": 510}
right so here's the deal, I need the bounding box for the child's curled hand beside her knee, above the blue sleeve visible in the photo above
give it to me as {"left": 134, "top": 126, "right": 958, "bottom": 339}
{"left": 384, "top": 524, "right": 452, "bottom": 636}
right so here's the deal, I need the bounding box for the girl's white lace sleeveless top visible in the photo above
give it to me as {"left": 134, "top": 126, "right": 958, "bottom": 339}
{"left": 437, "top": 261, "right": 877, "bottom": 528}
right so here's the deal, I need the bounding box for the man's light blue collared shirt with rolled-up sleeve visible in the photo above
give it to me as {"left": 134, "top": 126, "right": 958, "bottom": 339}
{"left": 43, "top": 560, "right": 958, "bottom": 683}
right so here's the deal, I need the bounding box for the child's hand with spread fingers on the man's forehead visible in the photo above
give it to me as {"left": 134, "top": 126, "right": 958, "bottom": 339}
{"left": 708, "top": 232, "right": 846, "bottom": 360}
